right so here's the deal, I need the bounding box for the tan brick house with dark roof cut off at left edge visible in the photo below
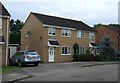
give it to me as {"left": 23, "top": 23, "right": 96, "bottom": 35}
{"left": 0, "top": 2, "right": 10, "bottom": 66}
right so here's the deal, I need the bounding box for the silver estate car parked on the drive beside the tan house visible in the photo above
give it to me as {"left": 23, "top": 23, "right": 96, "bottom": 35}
{"left": 10, "top": 51, "right": 41, "bottom": 66}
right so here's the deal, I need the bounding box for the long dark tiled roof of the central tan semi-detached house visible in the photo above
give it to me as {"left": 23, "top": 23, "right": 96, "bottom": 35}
{"left": 32, "top": 12, "right": 95, "bottom": 32}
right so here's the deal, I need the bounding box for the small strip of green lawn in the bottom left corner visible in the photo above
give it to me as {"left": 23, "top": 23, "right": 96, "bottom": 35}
{"left": 0, "top": 66, "right": 22, "bottom": 73}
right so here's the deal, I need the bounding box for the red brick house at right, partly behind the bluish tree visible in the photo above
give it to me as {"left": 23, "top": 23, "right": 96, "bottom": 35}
{"left": 96, "top": 25, "right": 120, "bottom": 51}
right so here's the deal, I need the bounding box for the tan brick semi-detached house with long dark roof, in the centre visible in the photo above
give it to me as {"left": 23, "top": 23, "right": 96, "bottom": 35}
{"left": 21, "top": 12, "right": 96, "bottom": 62}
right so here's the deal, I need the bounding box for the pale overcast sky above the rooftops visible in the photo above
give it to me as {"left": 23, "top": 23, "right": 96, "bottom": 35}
{"left": 0, "top": 0, "right": 120, "bottom": 26}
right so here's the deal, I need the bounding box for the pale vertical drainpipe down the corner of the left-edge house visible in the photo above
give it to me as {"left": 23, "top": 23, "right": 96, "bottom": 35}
{"left": 5, "top": 17, "right": 10, "bottom": 66}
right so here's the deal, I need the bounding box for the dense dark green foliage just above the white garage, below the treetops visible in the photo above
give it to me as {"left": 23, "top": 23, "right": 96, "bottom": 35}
{"left": 9, "top": 32, "right": 21, "bottom": 44}
